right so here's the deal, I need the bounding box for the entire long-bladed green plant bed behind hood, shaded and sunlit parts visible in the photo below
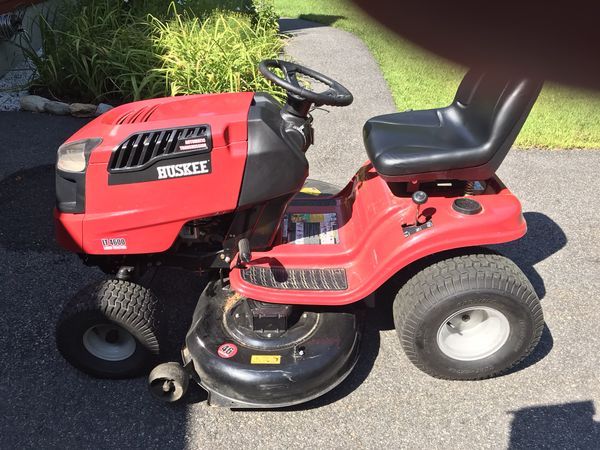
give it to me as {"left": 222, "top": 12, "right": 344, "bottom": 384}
{"left": 21, "top": 0, "right": 282, "bottom": 103}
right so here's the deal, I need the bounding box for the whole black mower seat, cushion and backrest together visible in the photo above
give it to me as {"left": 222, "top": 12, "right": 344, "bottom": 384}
{"left": 363, "top": 70, "right": 542, "bottom": 181}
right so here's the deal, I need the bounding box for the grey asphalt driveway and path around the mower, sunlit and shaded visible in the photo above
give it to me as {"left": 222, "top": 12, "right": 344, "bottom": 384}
{"left": 0, "top": 19, "right": 600, "bottom": 449}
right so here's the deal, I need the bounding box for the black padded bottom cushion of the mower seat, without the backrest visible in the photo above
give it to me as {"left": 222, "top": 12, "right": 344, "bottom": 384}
{"left": 363, "top": 108, "right": 489, "bottom": 179}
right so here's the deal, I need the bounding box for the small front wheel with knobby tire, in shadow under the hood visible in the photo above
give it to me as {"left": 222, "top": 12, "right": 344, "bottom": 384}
{"left": 56, "top": 280, "right": 159, "bottom": 378}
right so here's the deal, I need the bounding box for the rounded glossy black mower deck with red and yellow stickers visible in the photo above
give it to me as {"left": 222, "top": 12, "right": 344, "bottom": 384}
{"left": 182, "top": 280, "right": 363, "bottom": 408}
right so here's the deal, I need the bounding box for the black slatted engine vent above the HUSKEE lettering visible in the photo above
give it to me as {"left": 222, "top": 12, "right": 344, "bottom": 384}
{"left": 108, "top": 125, "right": 212, "bottom": 173}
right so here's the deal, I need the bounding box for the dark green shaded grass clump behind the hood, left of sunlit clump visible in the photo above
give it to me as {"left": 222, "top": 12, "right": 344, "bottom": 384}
{"left": 22, "top": 0, "right": 166, "bottom": 102}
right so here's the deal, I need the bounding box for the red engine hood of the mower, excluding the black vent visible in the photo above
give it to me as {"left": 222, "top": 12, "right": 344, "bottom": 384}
{"left": 60, "top": 92, "right": 254, "bottom": 254}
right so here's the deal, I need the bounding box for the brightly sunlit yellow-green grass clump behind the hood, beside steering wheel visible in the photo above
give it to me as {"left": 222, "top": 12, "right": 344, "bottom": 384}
{"left": 152, "top": 6, "right": 283, "bottom": 100}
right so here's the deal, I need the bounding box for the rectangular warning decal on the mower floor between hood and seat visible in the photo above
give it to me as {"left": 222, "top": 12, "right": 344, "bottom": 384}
{"left": 282, "top": 213, "right": 340, "bottom": 245}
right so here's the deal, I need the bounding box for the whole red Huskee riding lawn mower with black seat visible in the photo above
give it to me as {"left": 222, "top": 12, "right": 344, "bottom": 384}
{"left": 54, "top": 60, "right": 544, "bottom": 408}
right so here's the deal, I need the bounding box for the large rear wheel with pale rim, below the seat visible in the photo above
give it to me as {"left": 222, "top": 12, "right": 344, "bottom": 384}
{"left": 394, "top": 254, "right": 544, "bottom": 380}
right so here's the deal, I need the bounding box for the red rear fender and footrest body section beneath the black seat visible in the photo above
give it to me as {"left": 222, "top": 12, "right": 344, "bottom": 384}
{"left": 230, "top": 166, "right": 527, "bottom": 305}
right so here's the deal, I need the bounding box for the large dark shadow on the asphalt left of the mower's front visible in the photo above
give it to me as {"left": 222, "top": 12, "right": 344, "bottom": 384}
{"left": 0, "top": 113, "right": 191, "bottom": 449}
